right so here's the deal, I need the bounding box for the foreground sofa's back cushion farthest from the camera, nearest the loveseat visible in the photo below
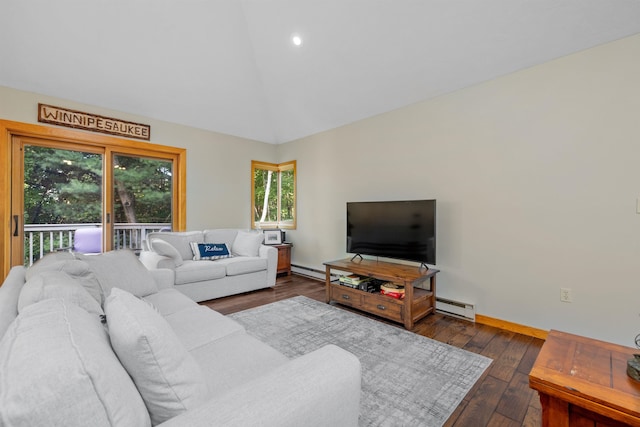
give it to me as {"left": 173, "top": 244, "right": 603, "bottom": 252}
{"left": 76, "top": 249, "right": 158, "bottom": 297}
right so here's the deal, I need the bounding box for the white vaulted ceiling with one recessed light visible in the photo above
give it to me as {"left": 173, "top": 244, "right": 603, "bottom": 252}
{"left": 0, "top": 0, "right": 640, "bottom": 143}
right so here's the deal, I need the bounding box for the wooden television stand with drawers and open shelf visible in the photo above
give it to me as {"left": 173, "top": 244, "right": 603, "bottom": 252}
{"left": 324, "top": 257, "right": 440, "bottom": 329}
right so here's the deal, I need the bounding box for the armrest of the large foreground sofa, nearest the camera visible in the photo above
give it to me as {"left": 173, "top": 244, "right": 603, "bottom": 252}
{"left": 161, "top": 345, "right": 361, "bottom": 427}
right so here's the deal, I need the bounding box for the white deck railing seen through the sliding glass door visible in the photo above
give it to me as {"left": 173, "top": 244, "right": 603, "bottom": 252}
{"left": 24, "top": 223, "right": 171, "bottom": 265}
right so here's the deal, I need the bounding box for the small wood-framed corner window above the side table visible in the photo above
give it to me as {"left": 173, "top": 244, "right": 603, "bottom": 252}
{"left": 251, "top": 160, "right": 296, "bottom": 229}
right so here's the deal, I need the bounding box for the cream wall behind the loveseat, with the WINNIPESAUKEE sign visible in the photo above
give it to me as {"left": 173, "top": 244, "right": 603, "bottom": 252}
{"left": 0, "top": 86, "right": 276, "bottom": 230}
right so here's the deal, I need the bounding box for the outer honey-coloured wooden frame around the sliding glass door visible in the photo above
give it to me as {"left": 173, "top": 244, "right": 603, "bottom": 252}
{"left": 0, "top": 120, "right": 187, "bottom": 283}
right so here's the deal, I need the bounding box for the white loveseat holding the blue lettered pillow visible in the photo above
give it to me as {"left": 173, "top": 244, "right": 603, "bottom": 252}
{"left": 140, "top": 229, "right": 278, "bottom": 301}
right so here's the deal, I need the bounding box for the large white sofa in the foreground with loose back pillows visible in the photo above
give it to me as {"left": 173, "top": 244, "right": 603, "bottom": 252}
{"left": 0, "top": 251, "right": 361, "bottom": 427}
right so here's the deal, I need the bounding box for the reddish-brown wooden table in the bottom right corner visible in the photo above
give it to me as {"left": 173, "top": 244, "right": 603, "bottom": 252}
{"left": 529, "top": 331, "right": 640, "bottom": 427}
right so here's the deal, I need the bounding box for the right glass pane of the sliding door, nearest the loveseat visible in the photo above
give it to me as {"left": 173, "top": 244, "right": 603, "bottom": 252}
{"left": 113, "top": 154, "right": 173, "bottom": 250}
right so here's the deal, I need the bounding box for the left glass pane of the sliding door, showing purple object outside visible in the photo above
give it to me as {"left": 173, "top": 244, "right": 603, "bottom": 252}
{"left": 22, "top": 144, "right": 103, "bottom": 265}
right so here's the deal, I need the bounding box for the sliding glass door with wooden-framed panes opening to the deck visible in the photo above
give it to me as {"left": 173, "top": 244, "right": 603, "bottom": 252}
{"left": 8, "top": 132, "right": 184, "bottom": 266}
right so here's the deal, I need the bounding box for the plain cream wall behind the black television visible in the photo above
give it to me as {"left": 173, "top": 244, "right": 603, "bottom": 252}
{"left": 278, "top": 36, "right": 640, "bottom": 345}
